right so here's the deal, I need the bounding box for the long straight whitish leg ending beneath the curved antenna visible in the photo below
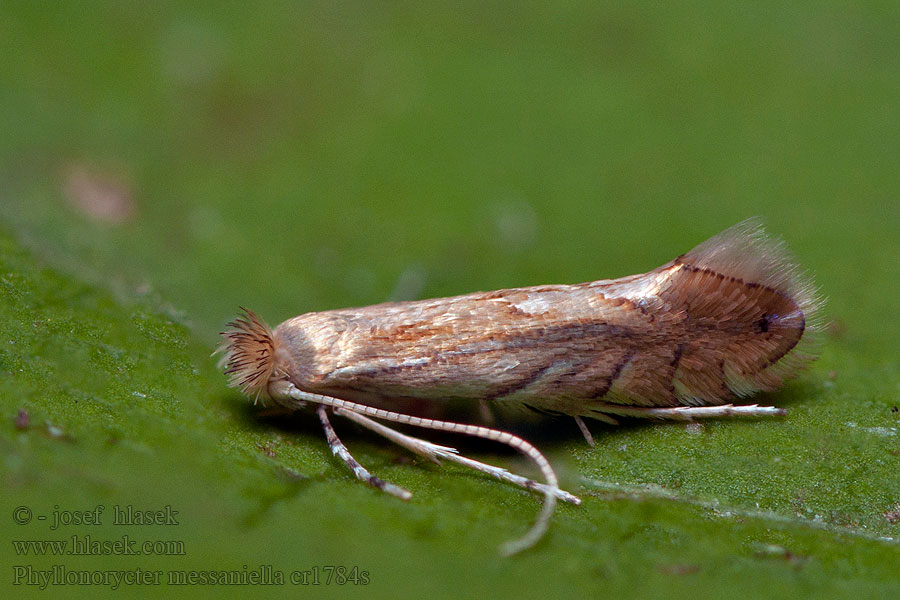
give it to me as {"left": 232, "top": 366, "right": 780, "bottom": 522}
{"left": 334, "top": 408, "right": 581, "bottom": 504}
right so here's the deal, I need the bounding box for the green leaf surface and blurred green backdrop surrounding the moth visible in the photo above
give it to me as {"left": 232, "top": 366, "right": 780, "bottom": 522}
{"left": 0, "top": 2, "right": 900, "bottom": 598}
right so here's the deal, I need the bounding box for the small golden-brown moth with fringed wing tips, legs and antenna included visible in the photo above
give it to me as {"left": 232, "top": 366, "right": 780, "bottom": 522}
{"left": 220, "top": 219, "right": 822, "bottom": 554}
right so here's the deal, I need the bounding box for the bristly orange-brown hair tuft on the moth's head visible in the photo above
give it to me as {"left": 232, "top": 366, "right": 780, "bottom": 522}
{"left": 216, "top": 307, "right": 277, "bottom": 404}
